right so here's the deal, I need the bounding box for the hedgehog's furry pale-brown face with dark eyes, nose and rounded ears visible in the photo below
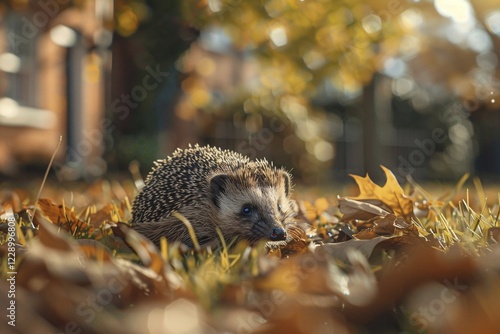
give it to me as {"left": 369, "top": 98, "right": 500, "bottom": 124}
{"left": 210, "top": 171, "right": 293, "bottom": 241}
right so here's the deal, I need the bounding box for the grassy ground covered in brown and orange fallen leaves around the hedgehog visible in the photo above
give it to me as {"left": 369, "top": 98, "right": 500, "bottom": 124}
{"left": 0, "top": 167, "right": 500, "bottom": 333}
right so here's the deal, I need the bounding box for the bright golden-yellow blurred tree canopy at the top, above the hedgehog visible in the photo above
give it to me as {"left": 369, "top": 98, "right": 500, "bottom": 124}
{"left": 183, "top": 0, "right": 405, "bottom": 97}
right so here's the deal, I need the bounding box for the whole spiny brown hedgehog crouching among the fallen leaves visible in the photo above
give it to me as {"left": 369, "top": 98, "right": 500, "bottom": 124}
{"left": 132, "top": 145, "right": 295, "bottom": 247}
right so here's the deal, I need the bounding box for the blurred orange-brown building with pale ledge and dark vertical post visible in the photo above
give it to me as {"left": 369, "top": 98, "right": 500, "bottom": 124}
{"left": 0, "top": 0, "right": 113, "bottom": 178}
